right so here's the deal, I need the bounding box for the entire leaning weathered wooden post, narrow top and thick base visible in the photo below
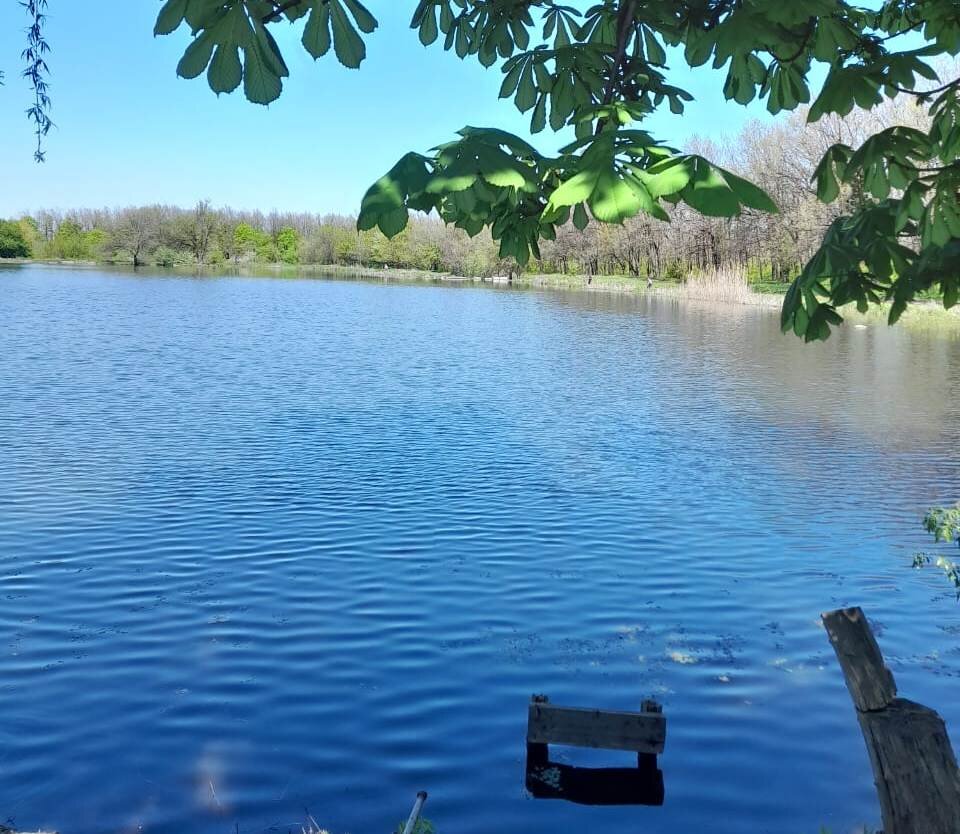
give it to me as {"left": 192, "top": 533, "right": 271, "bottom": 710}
{"left": 823, "top": 608, "right": 960, "bottom": 834}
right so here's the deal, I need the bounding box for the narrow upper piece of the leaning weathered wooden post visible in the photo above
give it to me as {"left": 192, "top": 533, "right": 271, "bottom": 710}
{"left": 822, "top": 608, "right": 897, "bottom": 712}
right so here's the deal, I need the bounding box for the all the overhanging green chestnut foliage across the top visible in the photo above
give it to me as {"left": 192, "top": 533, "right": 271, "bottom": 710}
{"left": 155, "top": 0, "right": 960, "bottom": 340}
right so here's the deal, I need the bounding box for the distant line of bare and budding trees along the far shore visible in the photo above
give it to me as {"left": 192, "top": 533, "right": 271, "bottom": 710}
{"left": 0, "top": 93, "right": 926, "bottom": 282}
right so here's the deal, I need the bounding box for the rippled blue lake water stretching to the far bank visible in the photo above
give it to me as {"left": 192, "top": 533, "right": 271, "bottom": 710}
{"left": 0, "top": 267, "right": 960, "bottom": 834}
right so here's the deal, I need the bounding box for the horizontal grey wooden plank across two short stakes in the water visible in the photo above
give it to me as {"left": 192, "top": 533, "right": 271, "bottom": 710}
{"left": 527, "top": 701, "right": 667, "bottom": 753}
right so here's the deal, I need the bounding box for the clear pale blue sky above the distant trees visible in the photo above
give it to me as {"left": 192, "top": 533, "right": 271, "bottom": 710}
{"left": 0, "top": 0, "right": 780, "bottom": 216}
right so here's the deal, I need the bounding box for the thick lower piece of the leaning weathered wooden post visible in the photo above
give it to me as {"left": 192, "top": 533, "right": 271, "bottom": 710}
{"left": 859, "top": 698, "right": 960, "bottom": 834}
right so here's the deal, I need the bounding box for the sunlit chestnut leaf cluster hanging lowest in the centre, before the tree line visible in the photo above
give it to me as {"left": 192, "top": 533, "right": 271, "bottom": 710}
{"left": 358, "top": 122, "right": 776, "bottom": 265}
